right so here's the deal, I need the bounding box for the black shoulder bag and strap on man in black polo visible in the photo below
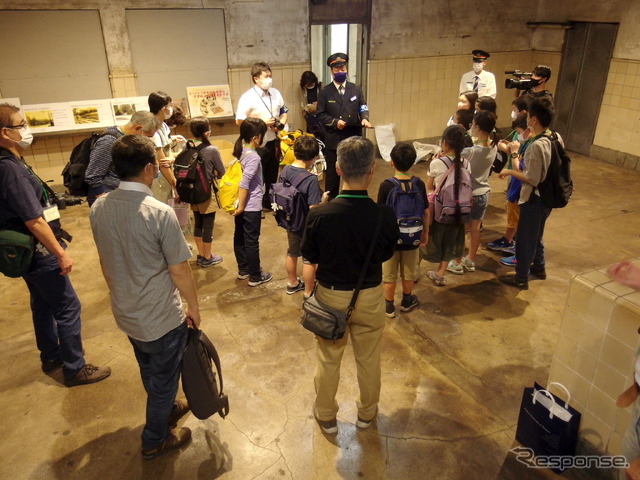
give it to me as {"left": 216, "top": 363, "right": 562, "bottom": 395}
{"left": 300, "top": 210, "right": 382, "bottom": 342}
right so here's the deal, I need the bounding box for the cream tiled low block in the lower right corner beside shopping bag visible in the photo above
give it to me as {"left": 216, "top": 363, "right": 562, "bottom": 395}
{"left": 549, "top": 260, "right": 640, "bottom": 455}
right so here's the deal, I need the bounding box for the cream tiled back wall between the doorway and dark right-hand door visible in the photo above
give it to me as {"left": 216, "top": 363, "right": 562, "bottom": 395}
{"left": 367, "top": 51, "right": 560, "bottom": 141}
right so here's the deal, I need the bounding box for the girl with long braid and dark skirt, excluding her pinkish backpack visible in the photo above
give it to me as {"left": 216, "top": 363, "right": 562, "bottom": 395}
{"left": 421, "top": 125, "right": 469, "bottom": 286}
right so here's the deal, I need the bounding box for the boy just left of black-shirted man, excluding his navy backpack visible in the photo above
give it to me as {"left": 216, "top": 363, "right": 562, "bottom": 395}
{"left": 274, "top": 135, "right": 328, "bottom": 298}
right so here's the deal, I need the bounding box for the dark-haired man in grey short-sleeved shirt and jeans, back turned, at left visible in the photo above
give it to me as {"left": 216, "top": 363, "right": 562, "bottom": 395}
{"left": 89, "top": 135, "right": 200, "bottom": 459}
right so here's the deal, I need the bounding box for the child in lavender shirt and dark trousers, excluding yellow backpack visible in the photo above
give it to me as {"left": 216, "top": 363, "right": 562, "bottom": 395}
{"left": 232, "top": 117, "right": 272, "bottom": 287}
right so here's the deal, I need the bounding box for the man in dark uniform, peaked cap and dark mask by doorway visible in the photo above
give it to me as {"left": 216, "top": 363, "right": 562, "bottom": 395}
{"left": 316, "top": 53, "right": 371, "bottom": 199}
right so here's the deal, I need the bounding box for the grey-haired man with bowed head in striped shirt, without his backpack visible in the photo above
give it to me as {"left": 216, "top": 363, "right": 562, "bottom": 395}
{"left": 84, "top": 110, "right": 160, "bottom": 206}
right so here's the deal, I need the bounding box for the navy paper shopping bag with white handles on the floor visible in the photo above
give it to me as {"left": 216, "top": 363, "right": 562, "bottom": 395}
{"left": 516, "top": 382, "right": 582, "bottom": 473}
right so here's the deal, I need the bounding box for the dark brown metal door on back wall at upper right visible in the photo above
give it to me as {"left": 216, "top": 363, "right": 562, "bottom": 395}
{"left": 553, "top": 22, "right": 618, "bottom": 156}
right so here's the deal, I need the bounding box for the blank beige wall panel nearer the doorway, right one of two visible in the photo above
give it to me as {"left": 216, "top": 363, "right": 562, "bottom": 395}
{"left": 126, "top": 8, "right": 229, "bottom": 103}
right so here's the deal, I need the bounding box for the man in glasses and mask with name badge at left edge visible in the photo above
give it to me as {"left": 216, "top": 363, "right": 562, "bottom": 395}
{"left": 0, "top": 103, "right": 111, "bottom": 387}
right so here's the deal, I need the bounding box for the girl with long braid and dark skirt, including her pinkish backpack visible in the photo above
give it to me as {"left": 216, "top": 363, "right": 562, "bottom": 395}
{"left": 423, "top": 125, "right": 471, "bottom": 286}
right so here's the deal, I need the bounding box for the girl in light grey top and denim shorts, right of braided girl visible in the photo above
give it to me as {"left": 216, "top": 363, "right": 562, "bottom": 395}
{"left": 447, "top": 110, "right": 498, "bottom": 275}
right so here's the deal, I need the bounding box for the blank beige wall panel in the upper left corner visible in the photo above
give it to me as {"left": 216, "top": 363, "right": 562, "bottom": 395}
{"left": 0, "top": 10, "right": 111, "bottom": 104}
